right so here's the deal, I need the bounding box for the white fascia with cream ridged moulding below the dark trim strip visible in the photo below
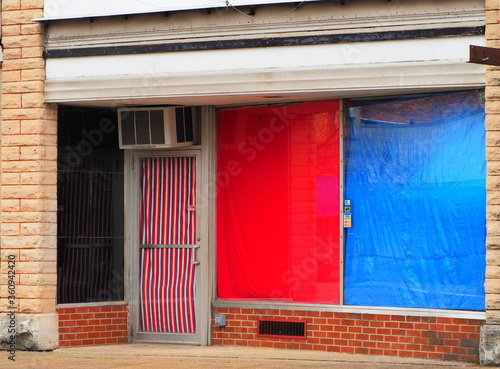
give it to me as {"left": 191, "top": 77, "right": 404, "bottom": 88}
{"left": 45, "top": 37, "right": 485, "bottom": 104}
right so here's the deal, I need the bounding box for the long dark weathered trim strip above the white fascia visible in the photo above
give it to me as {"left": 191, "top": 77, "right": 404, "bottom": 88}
{"left": 44, "top": 26, "right": 485, "bottom": 58}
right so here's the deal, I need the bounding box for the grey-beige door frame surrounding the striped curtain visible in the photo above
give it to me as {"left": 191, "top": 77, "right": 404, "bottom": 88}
{"left": 125, "top": 146, "right": 212, "bottom": 345}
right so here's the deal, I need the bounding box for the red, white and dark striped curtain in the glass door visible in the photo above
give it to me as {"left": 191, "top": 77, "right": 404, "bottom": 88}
{"left": 139, "top": 157, "right": 196, "bottom": 333}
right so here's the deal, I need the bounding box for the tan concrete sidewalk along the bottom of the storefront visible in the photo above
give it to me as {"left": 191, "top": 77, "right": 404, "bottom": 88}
{"left": 0, "top": 343, "right": 479, "bottom": 369}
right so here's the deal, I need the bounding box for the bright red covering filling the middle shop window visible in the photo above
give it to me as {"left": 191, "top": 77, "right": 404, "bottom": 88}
{"left": 217, "top": 100, "right": 340, "bottom": 304}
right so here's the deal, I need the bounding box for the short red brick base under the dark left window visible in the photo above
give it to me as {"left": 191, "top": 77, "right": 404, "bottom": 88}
{"left": 57, "top": 306, "right": 128, "bottom": 347}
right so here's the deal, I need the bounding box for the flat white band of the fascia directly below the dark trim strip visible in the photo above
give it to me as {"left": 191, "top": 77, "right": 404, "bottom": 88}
{"left": 46, "top": 36, "right": 485, "bottom": 80}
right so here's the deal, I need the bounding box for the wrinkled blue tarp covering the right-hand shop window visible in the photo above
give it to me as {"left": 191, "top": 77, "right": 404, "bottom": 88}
{"left": 344, "top": 92, "right": 486, "bottom": 310}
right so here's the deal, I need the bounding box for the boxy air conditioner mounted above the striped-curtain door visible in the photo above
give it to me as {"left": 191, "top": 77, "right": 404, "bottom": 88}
{"left": 118, "top": 107, "right": 199, "bottom": 149}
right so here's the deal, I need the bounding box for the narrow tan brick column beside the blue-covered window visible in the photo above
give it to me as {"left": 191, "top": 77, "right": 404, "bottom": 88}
{"left": 479, "top": 0, "right": 500, "bottom": 365}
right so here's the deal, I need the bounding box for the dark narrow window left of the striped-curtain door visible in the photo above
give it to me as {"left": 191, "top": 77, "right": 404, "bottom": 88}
{"left": 57, "top": 106, "right": 124, "bottom": 304}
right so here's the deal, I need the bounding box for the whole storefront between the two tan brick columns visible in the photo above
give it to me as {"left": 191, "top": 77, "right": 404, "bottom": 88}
{"left": 2, "top": 0, "right": 500, "bottom": 362}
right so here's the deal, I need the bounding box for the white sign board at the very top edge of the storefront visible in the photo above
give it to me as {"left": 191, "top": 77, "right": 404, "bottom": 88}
{"left": 43, "top": 0, "right": 316, "bottom": 20}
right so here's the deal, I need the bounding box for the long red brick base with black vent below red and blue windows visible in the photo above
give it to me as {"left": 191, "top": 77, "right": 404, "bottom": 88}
{"left": 212, "top": 308, "right": 485, "bottom": 362}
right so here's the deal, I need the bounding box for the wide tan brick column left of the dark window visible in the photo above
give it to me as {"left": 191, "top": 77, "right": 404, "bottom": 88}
{"left": 0, "top": 0, "right": 58, "bottom": 350}
